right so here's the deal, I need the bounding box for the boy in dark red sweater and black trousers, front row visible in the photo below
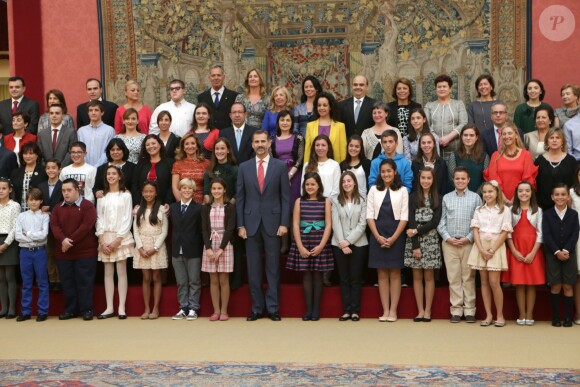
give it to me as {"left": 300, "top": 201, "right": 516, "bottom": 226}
{"left": 50, "top": 179, "right": 97, "bottom": 321}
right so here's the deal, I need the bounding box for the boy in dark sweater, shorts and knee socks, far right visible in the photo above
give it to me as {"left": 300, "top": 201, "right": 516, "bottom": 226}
{"left": 542, "top": 183, "right": 579, "bottom": 328}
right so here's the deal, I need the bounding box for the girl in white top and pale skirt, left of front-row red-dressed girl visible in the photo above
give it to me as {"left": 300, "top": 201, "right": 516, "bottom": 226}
{"left": 467, "top": 180, "right": 513, "bottom": 328}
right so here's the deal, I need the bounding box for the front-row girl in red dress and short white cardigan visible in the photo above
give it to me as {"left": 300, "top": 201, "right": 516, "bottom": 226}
{"left": 502, "top": 181, "right": 546, "bottom": 325}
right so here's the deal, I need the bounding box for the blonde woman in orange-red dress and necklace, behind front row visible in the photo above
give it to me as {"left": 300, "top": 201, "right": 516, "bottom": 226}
{"left": 483, "top": 124, "right": 538, "bottom": 206}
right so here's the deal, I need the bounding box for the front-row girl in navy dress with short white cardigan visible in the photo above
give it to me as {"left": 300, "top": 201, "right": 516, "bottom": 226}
{"left": 367, "top": 159, "right": 409, "bottom": 322}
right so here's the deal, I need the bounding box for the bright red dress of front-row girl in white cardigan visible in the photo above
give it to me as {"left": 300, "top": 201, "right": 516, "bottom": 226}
{"left": 501, "top": 209, "right": 546, "bottom": 285}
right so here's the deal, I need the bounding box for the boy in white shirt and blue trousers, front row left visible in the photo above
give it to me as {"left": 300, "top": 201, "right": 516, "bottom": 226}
{"left": 15, "top": 188, "right": 50, "bottom": 322}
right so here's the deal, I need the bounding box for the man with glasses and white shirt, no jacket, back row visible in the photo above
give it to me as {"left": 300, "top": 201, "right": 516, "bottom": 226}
{"left": 149, "top": 79, "right": 195, "bottom": 137}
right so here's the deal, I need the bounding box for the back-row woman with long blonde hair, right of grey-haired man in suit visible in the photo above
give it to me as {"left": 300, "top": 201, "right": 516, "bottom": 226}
{"left": 236, "top": 68, "right": 270, "bottom": 128}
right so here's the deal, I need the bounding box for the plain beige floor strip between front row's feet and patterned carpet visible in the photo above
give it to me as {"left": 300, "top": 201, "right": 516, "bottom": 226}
{"left": 0, "top": 317, "right": 580, "bottom": 368}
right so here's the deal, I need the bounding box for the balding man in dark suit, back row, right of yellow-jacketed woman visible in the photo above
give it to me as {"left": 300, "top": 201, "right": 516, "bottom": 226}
{"left": 338, "top": 75, "right": 377, "bottom": 138}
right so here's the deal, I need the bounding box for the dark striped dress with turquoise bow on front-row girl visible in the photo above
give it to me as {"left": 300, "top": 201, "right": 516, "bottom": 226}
{"left": 286, "top": 199, "right": 334, "bottom": 271}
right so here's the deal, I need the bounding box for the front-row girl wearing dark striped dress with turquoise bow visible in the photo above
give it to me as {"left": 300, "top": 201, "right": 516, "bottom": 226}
{"left": 286, "top": 172, "right": 334, "bottom": 321}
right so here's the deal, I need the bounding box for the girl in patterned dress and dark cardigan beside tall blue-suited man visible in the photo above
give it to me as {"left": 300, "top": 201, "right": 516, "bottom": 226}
{"left": 201, "top": 178, "right": 236, "bottom": 321}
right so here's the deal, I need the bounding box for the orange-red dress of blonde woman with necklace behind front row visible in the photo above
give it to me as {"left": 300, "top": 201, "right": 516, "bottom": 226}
{"left": 483, "top": 149, "right": 538, "bottom": 200}
